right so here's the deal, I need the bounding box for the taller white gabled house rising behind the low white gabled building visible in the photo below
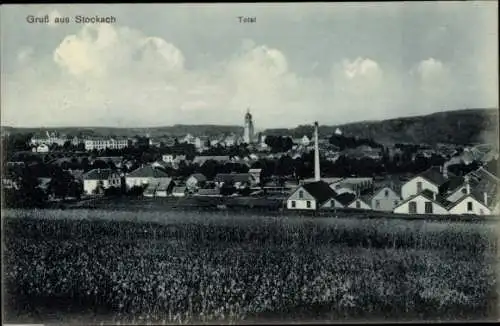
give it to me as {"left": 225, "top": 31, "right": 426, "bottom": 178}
{"left": 401, "top": 166, "right": 447, "bottom": 200}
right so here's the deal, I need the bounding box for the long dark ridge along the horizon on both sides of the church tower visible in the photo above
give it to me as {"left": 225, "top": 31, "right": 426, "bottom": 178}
{"left": 2, "top": 108, "right": 499, "bottom": 144}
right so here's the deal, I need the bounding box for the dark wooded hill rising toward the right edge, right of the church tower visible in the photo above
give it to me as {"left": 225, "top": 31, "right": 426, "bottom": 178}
{"left": 265, "top": 109, "right": 499, "bottom": 145}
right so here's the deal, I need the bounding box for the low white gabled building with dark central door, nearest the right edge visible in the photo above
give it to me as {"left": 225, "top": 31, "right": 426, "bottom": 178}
{"left": 448, "top": 189, "right": 494, "bottom": 215}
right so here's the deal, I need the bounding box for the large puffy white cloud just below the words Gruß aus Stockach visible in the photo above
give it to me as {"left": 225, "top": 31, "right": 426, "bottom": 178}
{"left": 54, "top": 24, "right": 184, "bottom": 78}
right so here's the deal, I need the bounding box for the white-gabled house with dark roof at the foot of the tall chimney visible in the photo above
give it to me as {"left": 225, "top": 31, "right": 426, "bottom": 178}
{"left": 286, "top": 181, "right": 338, "bottom": 210}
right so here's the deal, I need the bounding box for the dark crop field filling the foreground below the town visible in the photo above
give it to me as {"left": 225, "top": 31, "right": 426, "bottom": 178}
{"left": 3, "top": 209, "right": 498, "bottom": 324}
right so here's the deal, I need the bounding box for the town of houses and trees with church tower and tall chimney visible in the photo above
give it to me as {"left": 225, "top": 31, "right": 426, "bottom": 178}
{"left": 2, "top": 110, "right": 499, "bottom": 215}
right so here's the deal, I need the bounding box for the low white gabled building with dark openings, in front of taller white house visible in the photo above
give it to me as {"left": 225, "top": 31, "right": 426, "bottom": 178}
{"left": 394, "top": 189, "right": 450, "bottom": 215}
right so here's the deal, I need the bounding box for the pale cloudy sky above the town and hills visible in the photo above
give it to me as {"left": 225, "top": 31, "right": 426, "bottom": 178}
{"left": 0, "top": 1, "right": 499, "bottom": 129}
